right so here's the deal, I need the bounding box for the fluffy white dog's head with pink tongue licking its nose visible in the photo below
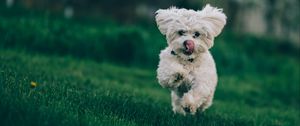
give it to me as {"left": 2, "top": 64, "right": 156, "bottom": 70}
{"left": 155, "top": 4, "right": 226, "bottom": 59}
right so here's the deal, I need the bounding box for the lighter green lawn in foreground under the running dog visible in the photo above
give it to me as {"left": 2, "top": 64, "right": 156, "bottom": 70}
{"left": 0, "top": 49, "right": 300, "bottom": 126}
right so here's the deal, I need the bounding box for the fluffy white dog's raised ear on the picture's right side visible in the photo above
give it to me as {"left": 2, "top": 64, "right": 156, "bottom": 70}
{"left": 200, "top": 4, "right": 227, "bottom": 37}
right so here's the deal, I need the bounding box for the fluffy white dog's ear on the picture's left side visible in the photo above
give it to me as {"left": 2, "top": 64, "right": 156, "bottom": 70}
{"left": 155, "top": 7, "right": 178, "bottom": 35}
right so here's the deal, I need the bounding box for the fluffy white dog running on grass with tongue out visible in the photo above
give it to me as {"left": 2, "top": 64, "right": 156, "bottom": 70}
{"left": 155, "top": 4, "right": 226, "bottom": 115}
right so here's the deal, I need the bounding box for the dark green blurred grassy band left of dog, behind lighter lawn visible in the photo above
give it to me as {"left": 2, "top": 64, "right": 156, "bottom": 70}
{"left": 0, "top": 16, "right": 165, "bottom": 66}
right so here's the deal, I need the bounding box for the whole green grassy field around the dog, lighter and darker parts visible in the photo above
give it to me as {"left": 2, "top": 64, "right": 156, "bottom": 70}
{"left": 0, "top": 7, "right": 300, "bottom": 126}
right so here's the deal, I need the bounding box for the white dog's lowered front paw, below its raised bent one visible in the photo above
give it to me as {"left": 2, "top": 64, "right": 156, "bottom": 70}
{"left": 181, "top": 93, "right": 197, "bottom": 114}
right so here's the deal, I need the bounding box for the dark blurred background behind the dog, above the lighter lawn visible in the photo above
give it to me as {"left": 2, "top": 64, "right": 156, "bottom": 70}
{"left": 0, "top": 0, "right": 300, "bottom": 66}
